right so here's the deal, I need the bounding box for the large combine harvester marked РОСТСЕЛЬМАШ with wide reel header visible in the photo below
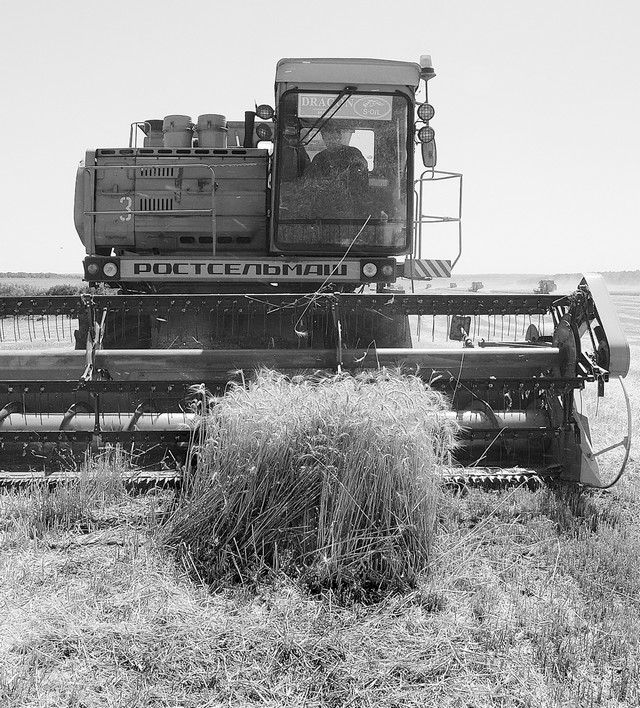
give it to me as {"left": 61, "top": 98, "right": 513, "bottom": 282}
{"left": 0, "top": 56, "right": 629, "bottom": 486}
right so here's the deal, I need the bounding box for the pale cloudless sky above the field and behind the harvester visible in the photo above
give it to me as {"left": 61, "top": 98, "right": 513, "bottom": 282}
{"left": 0, "top": 0, "right": 640, "bottom": 274}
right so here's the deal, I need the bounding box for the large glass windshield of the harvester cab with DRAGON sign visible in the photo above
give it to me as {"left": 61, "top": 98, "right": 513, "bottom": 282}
{"left": 274, "top": 91, "right": 413, "bottom": 254}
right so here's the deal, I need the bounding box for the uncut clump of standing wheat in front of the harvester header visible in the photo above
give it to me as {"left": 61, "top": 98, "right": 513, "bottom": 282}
{"left": 166, "top": 371, "right": 457, "bottom": 600}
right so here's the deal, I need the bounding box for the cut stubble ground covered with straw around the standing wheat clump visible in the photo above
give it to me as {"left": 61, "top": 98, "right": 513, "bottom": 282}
{"left": 0, "top": 296, "right": 640, "bottom": 708}
